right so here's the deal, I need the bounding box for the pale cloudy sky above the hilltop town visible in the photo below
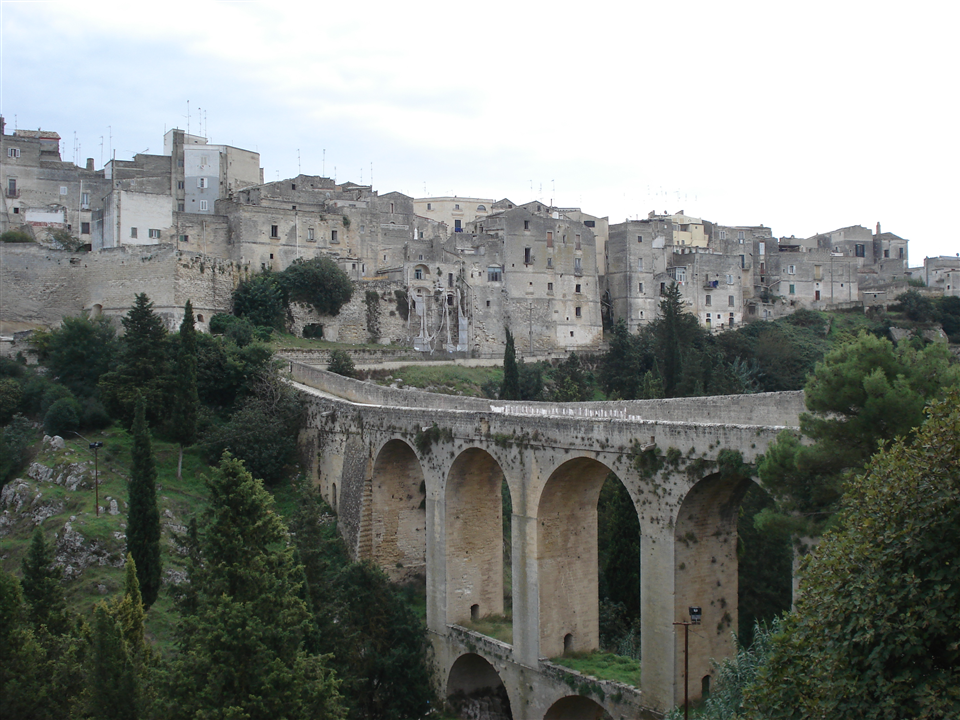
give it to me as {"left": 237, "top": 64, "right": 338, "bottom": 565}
{"left": 0, "top": 0, "right": 960, "bottom": 265}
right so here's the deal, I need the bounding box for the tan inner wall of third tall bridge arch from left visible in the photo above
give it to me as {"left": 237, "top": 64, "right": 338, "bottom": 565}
{"left": 537, "top": 457, "right": 611, "bottom": 657}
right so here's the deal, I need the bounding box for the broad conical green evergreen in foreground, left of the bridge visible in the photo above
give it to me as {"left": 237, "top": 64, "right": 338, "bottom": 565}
{"left": 170, "top": 453, "right": 343, "bottom": 720}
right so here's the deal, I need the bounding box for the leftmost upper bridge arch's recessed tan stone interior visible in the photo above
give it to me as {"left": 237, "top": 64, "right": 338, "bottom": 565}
{"left": 360, "top": 440, "right": 427, "bottom": 580}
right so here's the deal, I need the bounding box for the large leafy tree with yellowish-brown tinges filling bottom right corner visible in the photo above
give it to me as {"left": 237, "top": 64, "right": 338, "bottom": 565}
{"left": 746, "top": 392, "right": 960, "bottom": 720}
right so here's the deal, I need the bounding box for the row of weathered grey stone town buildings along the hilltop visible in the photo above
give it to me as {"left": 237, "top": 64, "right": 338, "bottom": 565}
{"left": 0, "top": 119, "right": 960, "bottom": 357}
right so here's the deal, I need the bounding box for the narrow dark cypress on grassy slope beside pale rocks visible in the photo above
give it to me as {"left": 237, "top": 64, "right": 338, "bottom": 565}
{"left": 127, "top": 397, "right": 161, "bottom": 608}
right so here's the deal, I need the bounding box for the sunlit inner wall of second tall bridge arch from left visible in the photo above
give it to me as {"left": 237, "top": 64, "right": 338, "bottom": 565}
{"left": 444, "top": 448, "right": 504, "bottom": 624}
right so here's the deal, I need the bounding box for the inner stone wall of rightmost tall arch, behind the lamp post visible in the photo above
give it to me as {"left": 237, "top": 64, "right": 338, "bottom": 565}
{"left": 674, "top": 473, "right": 753, "bottom": 702}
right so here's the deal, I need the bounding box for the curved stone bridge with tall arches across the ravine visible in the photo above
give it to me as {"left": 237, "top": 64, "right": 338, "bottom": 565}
{"left": 290, "top": 363, "right": 803, "bottom": 720}
